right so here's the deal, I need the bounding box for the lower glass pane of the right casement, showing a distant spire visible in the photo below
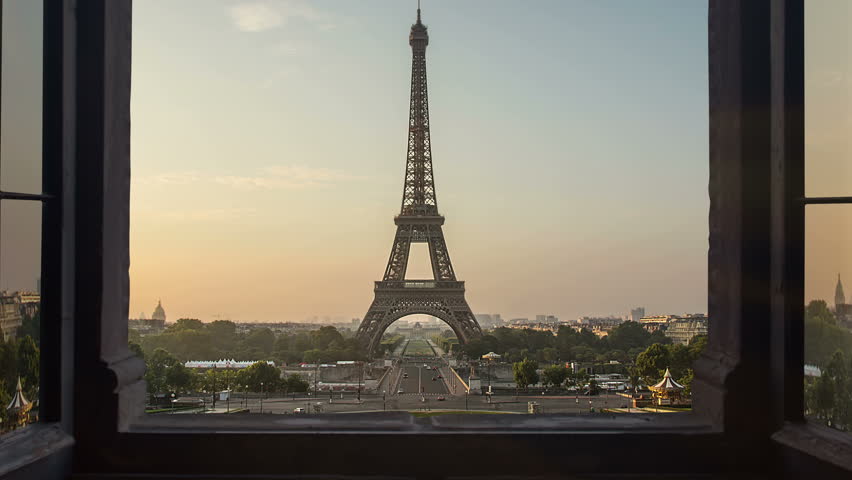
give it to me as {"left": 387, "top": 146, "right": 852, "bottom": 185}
{"left": 805, "top": 205, "right": 852, "bottom": 431}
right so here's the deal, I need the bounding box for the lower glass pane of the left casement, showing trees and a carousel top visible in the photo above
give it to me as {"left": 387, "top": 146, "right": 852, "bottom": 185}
{"left": 0, "top": 200, "right": 41, "bottom": 432}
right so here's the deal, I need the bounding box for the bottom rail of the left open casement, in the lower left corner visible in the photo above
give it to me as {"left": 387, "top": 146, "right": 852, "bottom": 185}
{"left": 0, "top": 423, "right": 74, "bottom": 477}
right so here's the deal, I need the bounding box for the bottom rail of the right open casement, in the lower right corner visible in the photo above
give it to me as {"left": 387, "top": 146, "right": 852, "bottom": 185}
{"left": 772, "top": 422, "right": 852, "bottom": 472}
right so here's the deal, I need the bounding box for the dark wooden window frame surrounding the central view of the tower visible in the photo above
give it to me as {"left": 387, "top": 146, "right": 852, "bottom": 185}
{"left": 0, "top": 0, "right": 852, "bottom": 478}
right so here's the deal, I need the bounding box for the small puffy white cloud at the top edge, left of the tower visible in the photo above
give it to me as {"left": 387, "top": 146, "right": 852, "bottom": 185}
{"left": 228, "top": 0, "right": 335, "bottom": 32}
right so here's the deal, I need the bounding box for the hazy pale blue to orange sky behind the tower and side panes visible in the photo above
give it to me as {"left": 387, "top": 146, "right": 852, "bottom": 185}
{"left": 0, "top": 0, "right": 852, "bottom": 321}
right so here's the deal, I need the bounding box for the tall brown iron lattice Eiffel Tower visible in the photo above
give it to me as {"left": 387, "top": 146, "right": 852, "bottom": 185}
{"left": 358, "top": 5, "right": 482, "bottom": 352}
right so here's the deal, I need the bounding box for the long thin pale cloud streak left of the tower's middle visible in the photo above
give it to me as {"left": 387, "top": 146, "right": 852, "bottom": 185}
{"left": 135, "top": 165, "right": 365, "bottom": 190}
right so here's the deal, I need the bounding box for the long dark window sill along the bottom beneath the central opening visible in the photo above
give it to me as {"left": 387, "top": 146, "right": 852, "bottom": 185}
{"left": 83, "top": 412, "right": 756, "bottom": 478}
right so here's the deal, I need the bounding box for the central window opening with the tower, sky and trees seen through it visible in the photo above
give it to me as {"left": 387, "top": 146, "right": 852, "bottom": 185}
{"left": 129, "top": 0, "right": 708, "bottom": 418}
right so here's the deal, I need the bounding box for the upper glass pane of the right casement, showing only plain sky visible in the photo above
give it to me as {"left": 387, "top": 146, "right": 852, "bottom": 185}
{"left": 805, "top": 0, "right": 852, "bottom": 197}
